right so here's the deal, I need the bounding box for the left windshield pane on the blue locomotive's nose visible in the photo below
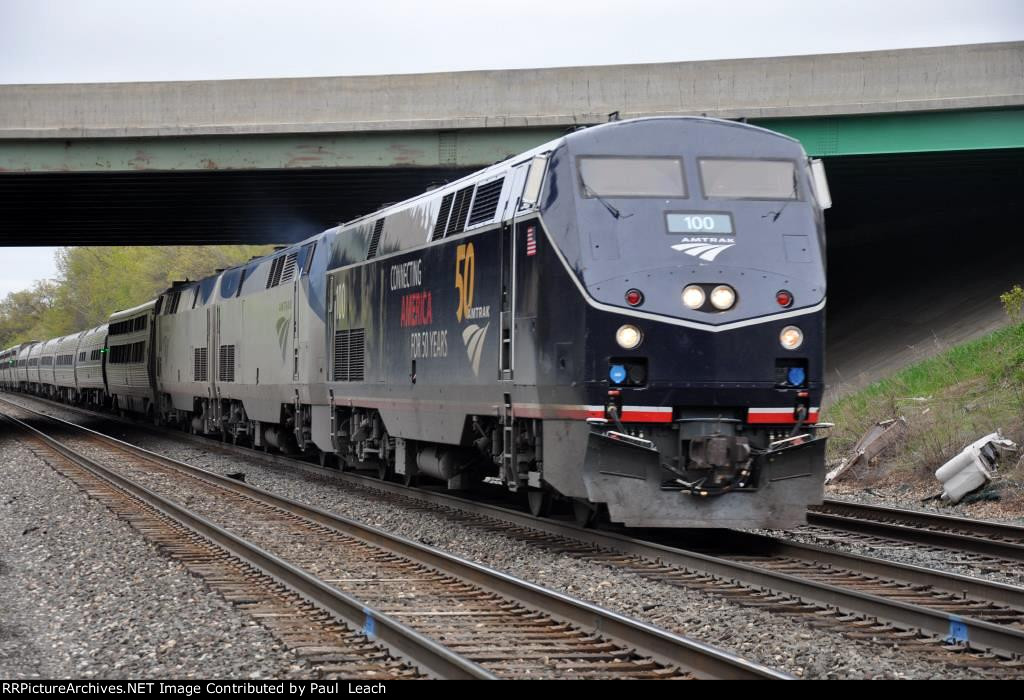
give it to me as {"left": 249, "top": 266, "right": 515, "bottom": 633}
{"left": 579, "top": 157, "right": 686, "bottom": 199}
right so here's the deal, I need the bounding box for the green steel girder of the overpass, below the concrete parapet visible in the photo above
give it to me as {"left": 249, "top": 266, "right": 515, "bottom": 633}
{"left": 0, "top": 107, "right": 1024, "bottom": 174}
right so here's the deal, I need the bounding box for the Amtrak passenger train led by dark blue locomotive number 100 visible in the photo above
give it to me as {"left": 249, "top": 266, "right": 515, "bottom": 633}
{"left": 0, "top": 118, "right": 828, "bottom": 527}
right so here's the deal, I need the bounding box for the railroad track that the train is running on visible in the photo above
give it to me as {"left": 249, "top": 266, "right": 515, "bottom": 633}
{"left": 6, "top": 392, "right": 1024, "bottom": 676}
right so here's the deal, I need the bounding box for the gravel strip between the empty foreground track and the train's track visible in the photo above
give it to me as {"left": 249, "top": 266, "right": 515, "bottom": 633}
{"left": 0, "top": 402, "right": 1003, "bottom": 679}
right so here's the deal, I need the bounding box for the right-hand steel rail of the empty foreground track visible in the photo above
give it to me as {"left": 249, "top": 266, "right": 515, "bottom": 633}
{"left": 0, "top": 398, "right": 793, "bottom": 680}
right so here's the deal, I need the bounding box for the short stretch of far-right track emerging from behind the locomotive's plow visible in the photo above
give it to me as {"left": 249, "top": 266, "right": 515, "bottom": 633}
{"left": 807, "top": 499, "right": 1024, "bottom": 570}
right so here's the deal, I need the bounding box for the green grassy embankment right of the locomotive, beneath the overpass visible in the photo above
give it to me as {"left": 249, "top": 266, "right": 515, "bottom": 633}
{"left": 824, "top": 323, "right": 1024, "bottom": 476}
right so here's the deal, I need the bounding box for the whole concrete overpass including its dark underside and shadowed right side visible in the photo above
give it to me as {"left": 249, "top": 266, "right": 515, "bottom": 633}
{"left": 0, "top": 42, "right": 1024, "bottom": 392}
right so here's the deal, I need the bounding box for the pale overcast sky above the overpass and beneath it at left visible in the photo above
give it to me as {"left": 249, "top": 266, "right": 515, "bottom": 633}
{"left": 0, "top": 0, "right": 1024, "bottom": 296}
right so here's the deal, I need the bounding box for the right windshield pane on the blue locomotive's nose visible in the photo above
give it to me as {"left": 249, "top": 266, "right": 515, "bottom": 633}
{"left": 699, "top": 158, "right": 797, "bottom": 200}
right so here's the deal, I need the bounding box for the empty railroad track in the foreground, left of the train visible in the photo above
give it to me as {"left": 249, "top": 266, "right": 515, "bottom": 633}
{"left": 4, "top": 404, "right": 788, "bottom": 679}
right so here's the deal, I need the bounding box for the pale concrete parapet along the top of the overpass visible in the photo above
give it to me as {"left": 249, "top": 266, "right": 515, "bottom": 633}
{"left": 0, "top": 42, "right": 1024, "bottom": 139}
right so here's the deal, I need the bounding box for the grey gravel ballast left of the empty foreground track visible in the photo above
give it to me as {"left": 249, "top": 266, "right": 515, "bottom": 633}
{"left": 0, "top": 427, "right": 303, "bottom": 679}
